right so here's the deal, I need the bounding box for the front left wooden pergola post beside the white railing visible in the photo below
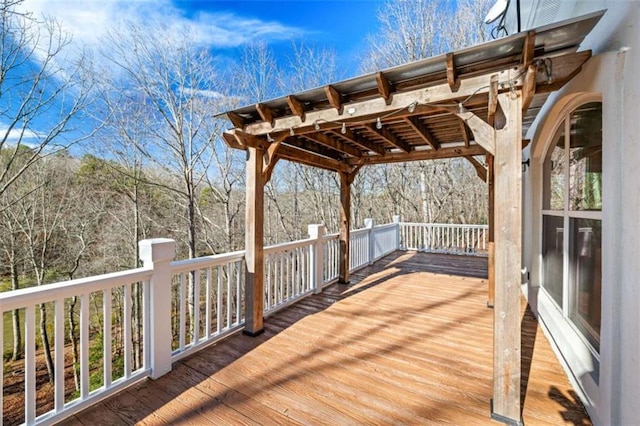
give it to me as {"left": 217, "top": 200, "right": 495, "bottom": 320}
{"left": 243, "top": 148, "right": 264, "bottom": 336}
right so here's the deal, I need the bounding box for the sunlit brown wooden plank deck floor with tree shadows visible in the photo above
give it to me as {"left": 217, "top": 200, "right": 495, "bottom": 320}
{"left": 67, "top": 252, "right": 590, "bottom": 426}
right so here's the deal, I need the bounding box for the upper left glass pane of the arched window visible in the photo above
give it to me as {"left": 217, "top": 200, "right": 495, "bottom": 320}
{"left": 542, "top": 123, "right": 566, "bottom": 210}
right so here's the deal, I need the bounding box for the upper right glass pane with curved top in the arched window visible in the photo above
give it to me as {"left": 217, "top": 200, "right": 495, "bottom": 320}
{"left": 569, "top": 102, "right": 602, "bottom": 210}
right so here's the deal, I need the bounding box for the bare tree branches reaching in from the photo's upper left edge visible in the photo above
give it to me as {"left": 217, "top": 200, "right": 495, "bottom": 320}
{"left": 0, "top": 0, "right": 92, "bottom": 199}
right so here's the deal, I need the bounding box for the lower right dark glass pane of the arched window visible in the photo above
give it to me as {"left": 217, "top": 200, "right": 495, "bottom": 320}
{"left": 569, "top": 218, "right": 602, "bottom": 351}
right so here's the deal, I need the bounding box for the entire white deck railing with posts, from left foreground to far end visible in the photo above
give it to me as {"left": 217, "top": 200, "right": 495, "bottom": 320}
{"left": 0, "top": 217, "right": 487, "bottom": 425}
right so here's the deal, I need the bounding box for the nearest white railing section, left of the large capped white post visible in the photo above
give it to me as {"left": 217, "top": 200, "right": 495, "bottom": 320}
{"left": 0, "top": 268, "right": 152, "bottom": 424}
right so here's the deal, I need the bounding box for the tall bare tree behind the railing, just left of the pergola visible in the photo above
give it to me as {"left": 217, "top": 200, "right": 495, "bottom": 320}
{"left": 103, "top": 22, "right": 224, "bottom": 336}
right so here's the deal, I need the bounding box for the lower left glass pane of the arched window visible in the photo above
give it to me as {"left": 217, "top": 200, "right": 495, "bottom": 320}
{"left": 542, "top": 215, "right": 564, "bottom": 307}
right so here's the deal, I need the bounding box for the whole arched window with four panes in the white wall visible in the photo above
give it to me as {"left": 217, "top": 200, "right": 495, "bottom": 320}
{"left": 541, "top": 102, "right": 602, "bottom": 351}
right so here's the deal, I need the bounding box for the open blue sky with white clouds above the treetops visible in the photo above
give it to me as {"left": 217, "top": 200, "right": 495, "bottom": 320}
{"left": 23, "top": 0, "right": 384, "bottom": 75}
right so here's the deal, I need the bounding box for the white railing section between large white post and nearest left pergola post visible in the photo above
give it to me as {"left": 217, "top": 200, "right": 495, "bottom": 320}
{"left": 171, "top": 251, "right": 245, "bottom": 361}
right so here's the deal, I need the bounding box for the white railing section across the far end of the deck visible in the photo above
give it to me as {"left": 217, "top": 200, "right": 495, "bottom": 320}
{"left": 399, "top": 223, "right": 489, "bottom": 255}
